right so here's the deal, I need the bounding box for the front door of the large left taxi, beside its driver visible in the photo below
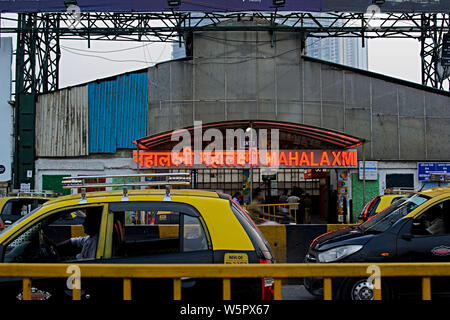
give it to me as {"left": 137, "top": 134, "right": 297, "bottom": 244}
{"left": 0, "top": 204, "right": 107, "bottom": 301}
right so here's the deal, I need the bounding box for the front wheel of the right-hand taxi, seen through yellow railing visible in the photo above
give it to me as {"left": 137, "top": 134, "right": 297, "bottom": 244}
{"left": 339, "top": 278, "right": 393, "bottom": 300}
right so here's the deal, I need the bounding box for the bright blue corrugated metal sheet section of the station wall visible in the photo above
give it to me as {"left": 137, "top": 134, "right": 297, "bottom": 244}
{"left": 88, "top": 72, "right": 148, "bottom": 153}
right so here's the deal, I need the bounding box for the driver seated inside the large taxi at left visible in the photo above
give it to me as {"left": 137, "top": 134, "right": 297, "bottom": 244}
{"left": 56, "top": 211, "right": 101, "bottom": 260}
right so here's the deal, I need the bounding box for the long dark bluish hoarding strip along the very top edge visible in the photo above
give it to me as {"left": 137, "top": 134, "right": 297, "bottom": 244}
{"left": 0, "top": 0, "right": 450, "bottom": 13}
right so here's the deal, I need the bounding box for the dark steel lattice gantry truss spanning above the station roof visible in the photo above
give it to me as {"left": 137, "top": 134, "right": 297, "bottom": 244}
{"left": 1, "top": 11, "right": 450, "bottom": 95}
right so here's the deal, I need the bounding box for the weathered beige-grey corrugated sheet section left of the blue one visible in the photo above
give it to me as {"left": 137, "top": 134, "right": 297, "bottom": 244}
{"left": 36, "top": 86, "right": 89, "bottom": 157}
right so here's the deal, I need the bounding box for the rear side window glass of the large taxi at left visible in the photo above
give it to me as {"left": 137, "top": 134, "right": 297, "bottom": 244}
{"left": 110, "top": 203, "right": 210, "bottom": 257}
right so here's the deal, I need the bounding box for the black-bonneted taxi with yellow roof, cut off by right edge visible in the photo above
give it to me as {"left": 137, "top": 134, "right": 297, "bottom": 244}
{"left": 304, "top": 187, "right": 450, "bottom": 300}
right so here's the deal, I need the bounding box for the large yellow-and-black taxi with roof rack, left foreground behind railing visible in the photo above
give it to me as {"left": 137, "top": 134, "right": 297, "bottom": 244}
{"left": 0, "top": 172, "right": 275, "bottom": 300}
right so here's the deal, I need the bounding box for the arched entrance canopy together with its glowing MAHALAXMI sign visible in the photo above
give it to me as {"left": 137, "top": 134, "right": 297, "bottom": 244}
{"left": 133, "top": 120, "right": 365, "bottom": 169}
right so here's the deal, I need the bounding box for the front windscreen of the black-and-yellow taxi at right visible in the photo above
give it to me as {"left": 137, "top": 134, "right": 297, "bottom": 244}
{"left": 359, "top": 194, "right": 430, "bottom": 233}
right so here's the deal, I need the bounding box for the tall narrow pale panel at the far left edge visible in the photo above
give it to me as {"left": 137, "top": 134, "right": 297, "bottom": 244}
{"left": 0, "top": 38, "right": 13, "bottom": 182}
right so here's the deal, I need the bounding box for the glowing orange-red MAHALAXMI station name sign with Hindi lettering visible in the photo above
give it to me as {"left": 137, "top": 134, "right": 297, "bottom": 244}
{"left": 133, "top": 148, "right": 358, "bottom": 169}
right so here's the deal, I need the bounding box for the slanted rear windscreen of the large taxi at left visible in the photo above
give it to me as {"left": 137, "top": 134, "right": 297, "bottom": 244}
{"left": 230, "top": 201, "right": 273, "bottom": 260}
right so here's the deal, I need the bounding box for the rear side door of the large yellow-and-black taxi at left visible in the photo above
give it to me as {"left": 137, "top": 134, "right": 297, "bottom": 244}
{"left": 105, "top": 202, "right": 213, "bottom": 300}
